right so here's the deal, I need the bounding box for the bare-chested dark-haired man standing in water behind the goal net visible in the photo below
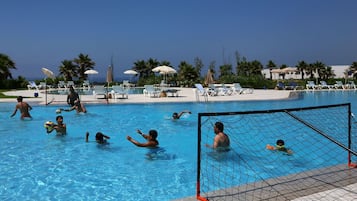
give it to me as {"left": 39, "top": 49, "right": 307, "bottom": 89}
{"left": 206, "top": 122, "right": 230, "bottom": 151}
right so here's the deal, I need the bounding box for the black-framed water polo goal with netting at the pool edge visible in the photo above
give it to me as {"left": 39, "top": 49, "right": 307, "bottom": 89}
{"left": 196, "top": 103, "right": 357, "bottom": 201}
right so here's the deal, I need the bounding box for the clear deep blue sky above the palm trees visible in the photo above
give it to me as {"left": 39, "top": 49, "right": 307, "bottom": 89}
{"left": 0, "top": 0, "right": 357, "bottom": 78}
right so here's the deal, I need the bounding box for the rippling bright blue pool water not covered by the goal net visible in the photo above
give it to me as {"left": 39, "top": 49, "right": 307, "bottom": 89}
{"left": 0, "top": 91, "right": 357, "bottom": 201}
